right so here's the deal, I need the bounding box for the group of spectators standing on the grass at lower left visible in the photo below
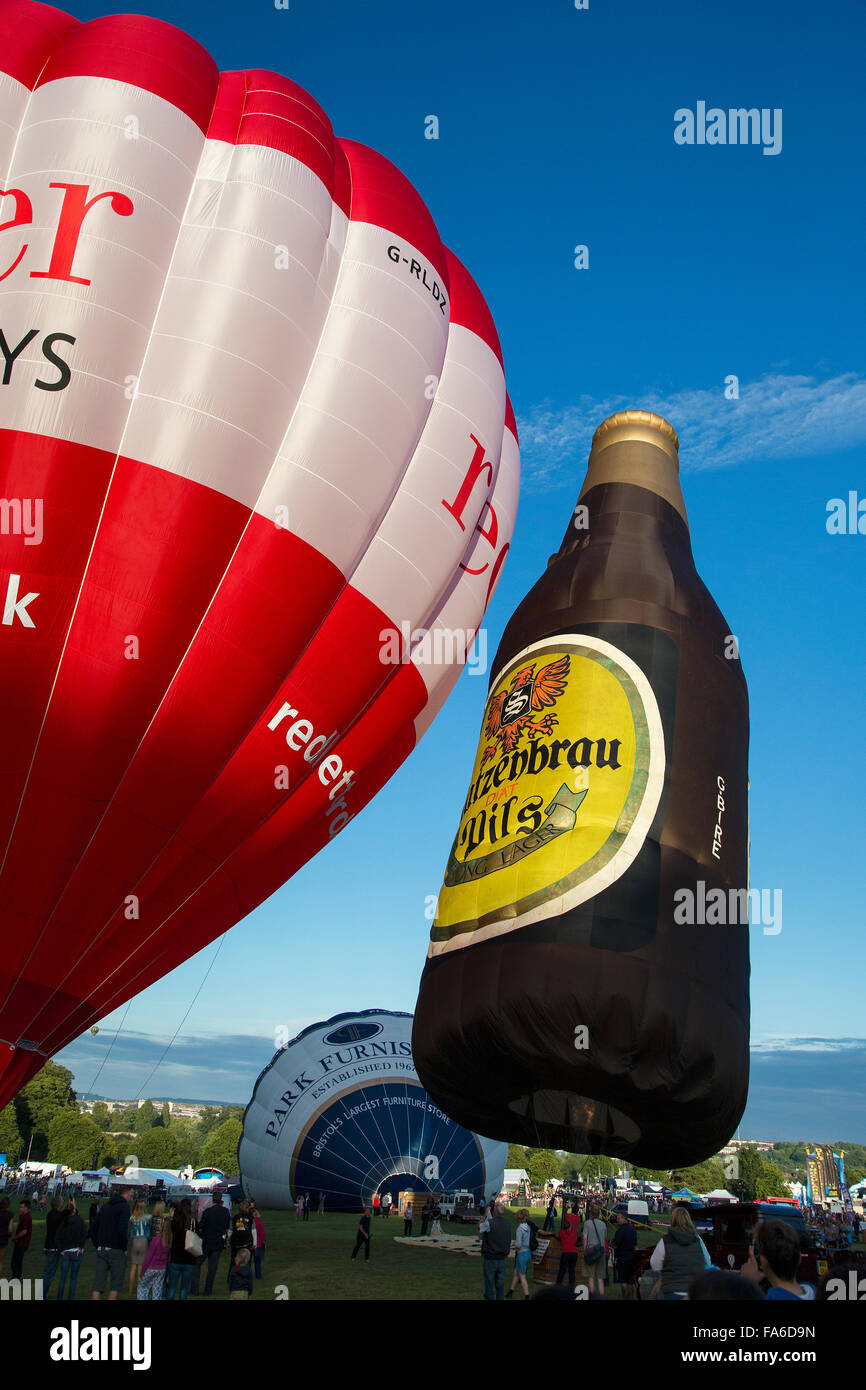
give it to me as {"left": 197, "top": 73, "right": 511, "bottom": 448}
{"left": 0, "top": 1187, "right": 267, "bottom": 1302}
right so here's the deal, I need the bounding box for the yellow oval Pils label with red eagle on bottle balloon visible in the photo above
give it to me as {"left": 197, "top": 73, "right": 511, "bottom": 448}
{"left": 430, "top": 634, "right": 664, "bottom": 955}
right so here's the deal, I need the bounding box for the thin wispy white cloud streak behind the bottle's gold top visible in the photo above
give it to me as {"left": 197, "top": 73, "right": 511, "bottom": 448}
{"left": 517, "top": 371, "right": 866, "bottom": 492}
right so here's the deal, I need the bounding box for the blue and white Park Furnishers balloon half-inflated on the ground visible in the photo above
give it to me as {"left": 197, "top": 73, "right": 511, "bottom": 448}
{"left": 238, "top": 1009, "right": 507, "bottom": 1211}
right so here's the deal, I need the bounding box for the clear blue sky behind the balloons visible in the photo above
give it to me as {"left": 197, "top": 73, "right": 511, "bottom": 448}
{"left": 55, "top": 0, "right": 866, "bottom": 1141}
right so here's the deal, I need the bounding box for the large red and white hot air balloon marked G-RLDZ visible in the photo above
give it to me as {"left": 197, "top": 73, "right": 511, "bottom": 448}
{"left": 0, "top": 0, "right": 518, "bottom": 1105}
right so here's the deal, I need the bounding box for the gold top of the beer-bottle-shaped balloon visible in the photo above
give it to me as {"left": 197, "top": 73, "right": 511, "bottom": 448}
{"left": 580, "top": 410, "right": 688, "bottom": 525}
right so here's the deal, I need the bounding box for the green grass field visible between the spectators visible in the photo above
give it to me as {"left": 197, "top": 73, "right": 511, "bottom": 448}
{"left": 3, "top": 1204, "right": 664, "bottom": 1302}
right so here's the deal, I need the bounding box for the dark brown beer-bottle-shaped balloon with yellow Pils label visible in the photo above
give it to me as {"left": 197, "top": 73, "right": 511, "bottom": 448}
{"left": 413, "top": 410, "right": 749, "bottom": 1168}
